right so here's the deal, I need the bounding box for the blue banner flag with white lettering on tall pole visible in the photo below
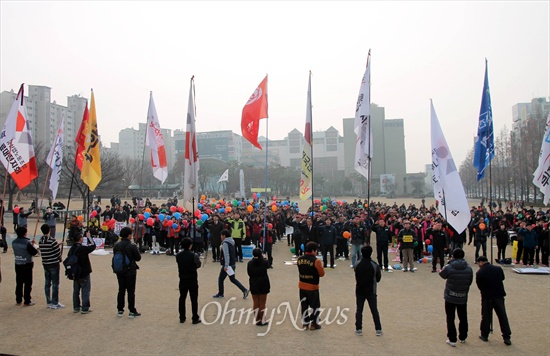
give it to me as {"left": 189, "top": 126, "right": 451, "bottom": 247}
{"left": 474, "top": 59, "right": 495, "bottom": 181}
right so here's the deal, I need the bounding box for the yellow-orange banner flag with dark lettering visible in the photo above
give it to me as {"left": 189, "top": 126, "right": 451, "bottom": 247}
{"left": 80, "top": 90, "right": 101, "bottom": 192}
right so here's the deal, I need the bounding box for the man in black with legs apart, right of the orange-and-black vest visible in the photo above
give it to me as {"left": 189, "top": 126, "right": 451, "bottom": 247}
{"left": 355, "top": 246, "right": 382, "bottom": 336}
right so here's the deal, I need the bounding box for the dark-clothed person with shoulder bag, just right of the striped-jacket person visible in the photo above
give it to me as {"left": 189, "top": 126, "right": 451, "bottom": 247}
{"left": 68, "top": 232, "right": 95, "bottom": 314}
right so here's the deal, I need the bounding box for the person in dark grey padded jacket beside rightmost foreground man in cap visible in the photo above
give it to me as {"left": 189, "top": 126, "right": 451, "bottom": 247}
{"left": 439, "top": 248, "right": 474, "bottom": 347}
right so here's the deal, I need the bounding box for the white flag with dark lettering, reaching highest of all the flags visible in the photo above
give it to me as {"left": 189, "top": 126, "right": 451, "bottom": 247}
{"left": 354, "top": 50, "right": 373, "bottom": 179}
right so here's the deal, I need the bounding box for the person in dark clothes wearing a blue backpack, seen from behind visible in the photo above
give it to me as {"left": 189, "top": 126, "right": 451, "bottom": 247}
{"left": 113, "top": 227, "right": 141, "bottom": 319}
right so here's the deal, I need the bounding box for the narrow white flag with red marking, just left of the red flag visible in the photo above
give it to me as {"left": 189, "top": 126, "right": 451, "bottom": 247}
{"left": 183, "top": 77, "right": 199, "bottom": 201}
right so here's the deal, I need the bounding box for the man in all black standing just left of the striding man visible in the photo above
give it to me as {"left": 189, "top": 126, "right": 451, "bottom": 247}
{"left": 176, "top": 238, "right": 201, "bottom": 324}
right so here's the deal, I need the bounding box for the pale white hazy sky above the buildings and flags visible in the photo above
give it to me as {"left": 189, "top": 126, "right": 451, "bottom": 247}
{"left": 0, "top": 0, "right": 550, "bottom": 173}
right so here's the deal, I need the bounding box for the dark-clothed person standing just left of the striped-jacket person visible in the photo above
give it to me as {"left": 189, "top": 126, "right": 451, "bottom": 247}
{"left": 11, "top": 226, "right": 38, "bottom": 306}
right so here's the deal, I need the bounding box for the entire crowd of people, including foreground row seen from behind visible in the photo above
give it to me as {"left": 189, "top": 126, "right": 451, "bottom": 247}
{"left": 0, "top": 195, "right": 550, "bottom": 346}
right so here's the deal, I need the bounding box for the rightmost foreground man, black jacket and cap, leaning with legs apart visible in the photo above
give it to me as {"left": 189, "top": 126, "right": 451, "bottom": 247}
{"left": 476, "top": 256, "right": 512, "bottom": 346}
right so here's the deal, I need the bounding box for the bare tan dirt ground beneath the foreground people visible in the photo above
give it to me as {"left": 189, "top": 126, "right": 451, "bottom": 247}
{"left": 0, "top": 199, "right": 550, "bottom": 355}
